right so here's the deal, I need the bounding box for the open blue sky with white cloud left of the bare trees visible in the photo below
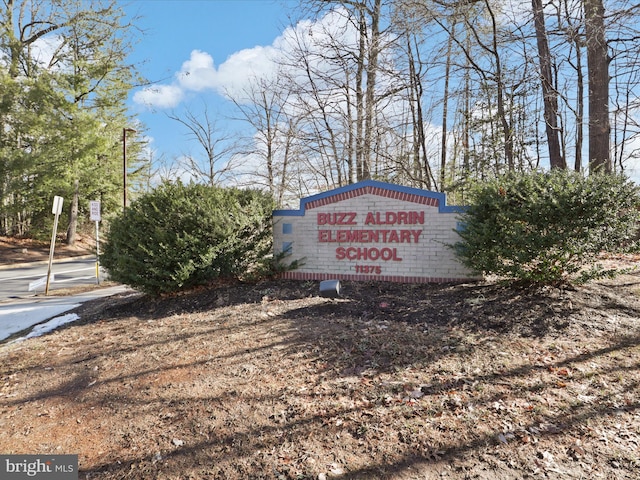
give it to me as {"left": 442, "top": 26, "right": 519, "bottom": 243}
{"left": 123, "top": 0, "right": 298, "bottom": 171}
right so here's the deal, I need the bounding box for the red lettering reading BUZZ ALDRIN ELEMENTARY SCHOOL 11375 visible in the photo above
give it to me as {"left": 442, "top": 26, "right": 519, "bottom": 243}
{"left": 317, "top": 211, "right": 424, "bottom": 274}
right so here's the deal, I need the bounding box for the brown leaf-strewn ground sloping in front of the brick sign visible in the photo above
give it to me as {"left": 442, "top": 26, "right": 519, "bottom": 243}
{"left": 0, "top": 238, "right": 640, "bottom": 480}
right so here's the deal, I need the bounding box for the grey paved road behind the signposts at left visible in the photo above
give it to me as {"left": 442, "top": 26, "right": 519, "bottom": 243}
{"left": 0, "top": 258, "right": 101, "bottom": 301}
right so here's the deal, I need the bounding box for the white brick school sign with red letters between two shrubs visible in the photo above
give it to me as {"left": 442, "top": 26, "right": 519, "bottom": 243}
{"left": 273, "top": 180, "right": 472, "bottom": 283}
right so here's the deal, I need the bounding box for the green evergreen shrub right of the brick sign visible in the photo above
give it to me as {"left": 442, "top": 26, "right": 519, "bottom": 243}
{"left": 454, "top": 170, "right": 640, "bottom": 284}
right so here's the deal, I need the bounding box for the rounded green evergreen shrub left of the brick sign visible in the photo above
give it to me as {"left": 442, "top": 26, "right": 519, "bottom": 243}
{"left": 100, "top": 182, "right": 273, "bottom": 295}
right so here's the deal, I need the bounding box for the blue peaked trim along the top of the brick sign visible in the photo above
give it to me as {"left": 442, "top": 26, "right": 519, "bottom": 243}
{"left": 273, "top": 180, "right": 468, "bottom": 217}
